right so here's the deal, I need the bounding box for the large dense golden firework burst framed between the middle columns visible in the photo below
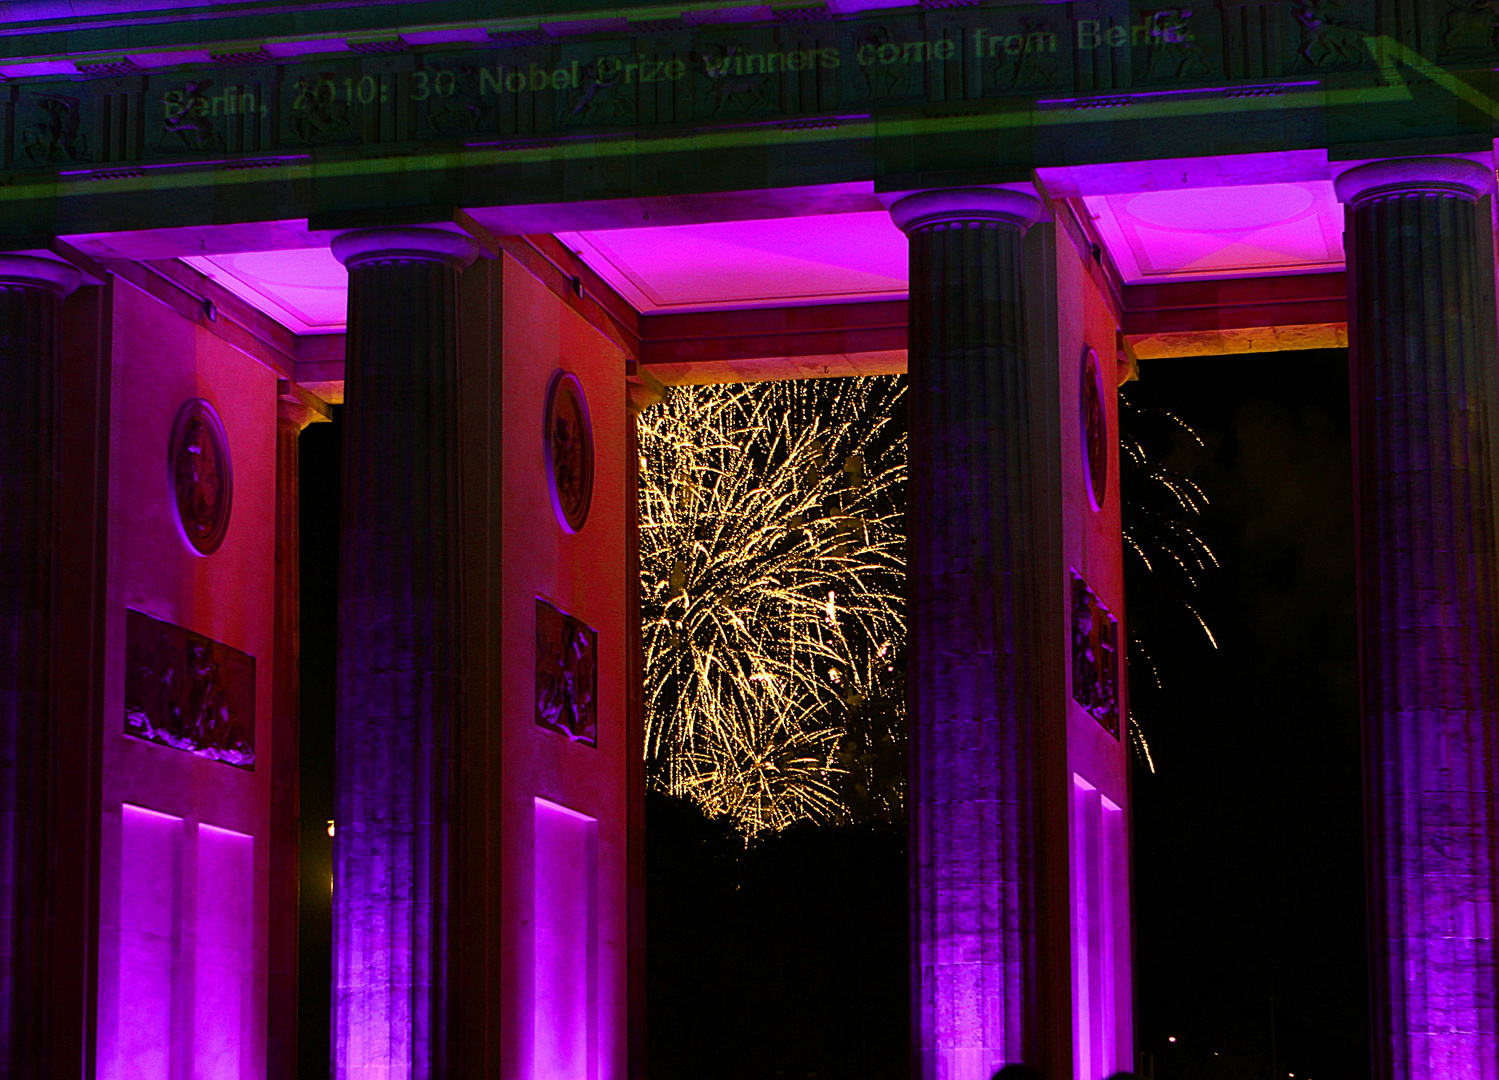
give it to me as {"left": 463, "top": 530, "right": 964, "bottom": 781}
{"left": 639, "top": 378, "right": 905, "bottom": 836}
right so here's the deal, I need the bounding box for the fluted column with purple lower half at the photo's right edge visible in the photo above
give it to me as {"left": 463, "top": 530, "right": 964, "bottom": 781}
{"left": 1337, "top": 158, "right": 1499, "bottom": 1080}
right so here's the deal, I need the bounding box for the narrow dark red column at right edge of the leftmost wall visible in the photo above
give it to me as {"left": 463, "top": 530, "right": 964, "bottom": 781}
{"left": 265, "top": 380, "right": 328, "bottom": 1080}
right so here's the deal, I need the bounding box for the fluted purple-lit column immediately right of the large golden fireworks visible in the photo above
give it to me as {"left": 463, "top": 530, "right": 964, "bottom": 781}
{"left": 890, "top": 189, "right": 1043, "bottom": 1080}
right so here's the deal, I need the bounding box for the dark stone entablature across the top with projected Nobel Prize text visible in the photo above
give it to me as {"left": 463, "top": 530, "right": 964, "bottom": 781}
{"left": 0, "top": 0, "right": 1499, "bottom": 242}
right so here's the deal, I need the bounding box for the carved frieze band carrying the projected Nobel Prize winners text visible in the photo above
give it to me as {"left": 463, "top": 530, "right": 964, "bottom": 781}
{"left": 6, "top": 0, "right": 1439, "bottom": 173}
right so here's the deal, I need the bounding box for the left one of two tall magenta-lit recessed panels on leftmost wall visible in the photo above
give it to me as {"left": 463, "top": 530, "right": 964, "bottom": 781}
{"left": 109, "top": 804, "right": 183, "bottom": 1080}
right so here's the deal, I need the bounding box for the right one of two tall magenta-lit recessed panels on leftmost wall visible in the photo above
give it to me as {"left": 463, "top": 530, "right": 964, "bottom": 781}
{"left": 192, "top": 825, "right": 255, "bottom": 1080}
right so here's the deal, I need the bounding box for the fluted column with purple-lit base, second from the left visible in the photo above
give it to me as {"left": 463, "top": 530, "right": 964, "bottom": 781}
{"left": 333, "top": 228, "right": 478, "bottom": 1080}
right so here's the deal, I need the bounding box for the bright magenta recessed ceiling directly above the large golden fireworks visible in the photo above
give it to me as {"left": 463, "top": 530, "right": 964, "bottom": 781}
{"left": 558, "top": 210, "right": 907, "bottom": 314}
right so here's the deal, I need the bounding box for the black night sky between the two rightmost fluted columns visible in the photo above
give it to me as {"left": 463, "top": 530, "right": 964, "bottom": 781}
{"left": 1124, "top": 350, "right": 1369, "bottom": 1080}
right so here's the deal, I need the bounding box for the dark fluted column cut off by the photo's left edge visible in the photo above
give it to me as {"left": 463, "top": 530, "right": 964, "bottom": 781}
{"left": 0, "top": 255, "right": 79, "bottom": 1077}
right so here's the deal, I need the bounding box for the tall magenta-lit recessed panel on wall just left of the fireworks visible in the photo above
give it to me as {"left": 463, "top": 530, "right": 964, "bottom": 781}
{"left": 531, "top": 798, "right": 598, "bottom": 1080}
